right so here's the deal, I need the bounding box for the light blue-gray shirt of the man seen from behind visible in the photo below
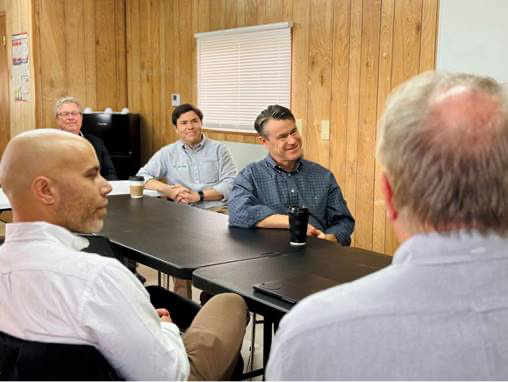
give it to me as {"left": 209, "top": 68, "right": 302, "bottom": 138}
{"left": 266, "top": 231, "right": 508, "bottom": 382}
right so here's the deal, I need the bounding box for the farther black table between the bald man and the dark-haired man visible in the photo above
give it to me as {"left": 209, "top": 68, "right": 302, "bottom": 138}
{"left": 101, "top": 195, "right": 338, "bottom": 280}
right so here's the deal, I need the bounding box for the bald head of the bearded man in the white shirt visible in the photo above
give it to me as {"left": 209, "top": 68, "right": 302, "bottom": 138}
{"left": 0, "top": 129, "right": 111, "bottom": 232}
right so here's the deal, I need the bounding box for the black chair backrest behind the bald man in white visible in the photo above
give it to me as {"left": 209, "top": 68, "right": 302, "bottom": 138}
{"left": 0, "top": 332, "right": 124, "bottom": 382}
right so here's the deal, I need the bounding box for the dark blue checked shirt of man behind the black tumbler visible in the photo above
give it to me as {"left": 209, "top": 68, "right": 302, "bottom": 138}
{"left": 229, "top": 155, "right": 355, "bottom": 246}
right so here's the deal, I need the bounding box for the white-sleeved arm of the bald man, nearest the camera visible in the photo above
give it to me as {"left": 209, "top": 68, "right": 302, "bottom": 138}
{"left": 79, "top": 263, "right": 190, "bottom": 381}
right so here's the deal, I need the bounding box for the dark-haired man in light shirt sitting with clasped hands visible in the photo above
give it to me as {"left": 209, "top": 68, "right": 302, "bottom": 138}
{"left": 138, "top": 104, "right": 238, "bottom": 212}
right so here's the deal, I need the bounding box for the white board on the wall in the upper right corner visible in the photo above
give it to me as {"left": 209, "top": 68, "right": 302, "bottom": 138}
{"left": 436, "top": 0, "right": 508, "bottom": 82}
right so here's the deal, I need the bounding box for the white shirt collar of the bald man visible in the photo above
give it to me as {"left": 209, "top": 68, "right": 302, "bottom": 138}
{"left": 5, "top": 222, "right": 89, "bottom": 251}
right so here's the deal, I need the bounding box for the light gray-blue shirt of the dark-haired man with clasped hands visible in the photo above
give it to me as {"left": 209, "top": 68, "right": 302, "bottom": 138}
{"left": 137, "top": 136, "right": 238, "bottom": 209}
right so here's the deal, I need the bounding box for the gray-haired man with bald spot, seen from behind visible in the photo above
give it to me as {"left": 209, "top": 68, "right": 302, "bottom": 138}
{"left": 266, "top": 72, "right": 508, "bottom": 382}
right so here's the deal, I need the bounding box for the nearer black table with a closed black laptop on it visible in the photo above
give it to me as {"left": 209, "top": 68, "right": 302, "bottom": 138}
{"left": 192, "top": 245, "right": 392, "bottom": 365}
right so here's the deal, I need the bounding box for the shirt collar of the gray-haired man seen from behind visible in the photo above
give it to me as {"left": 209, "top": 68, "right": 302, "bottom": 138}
{"left": 393, "top": 230, "right": 508, "bottom": 265}
